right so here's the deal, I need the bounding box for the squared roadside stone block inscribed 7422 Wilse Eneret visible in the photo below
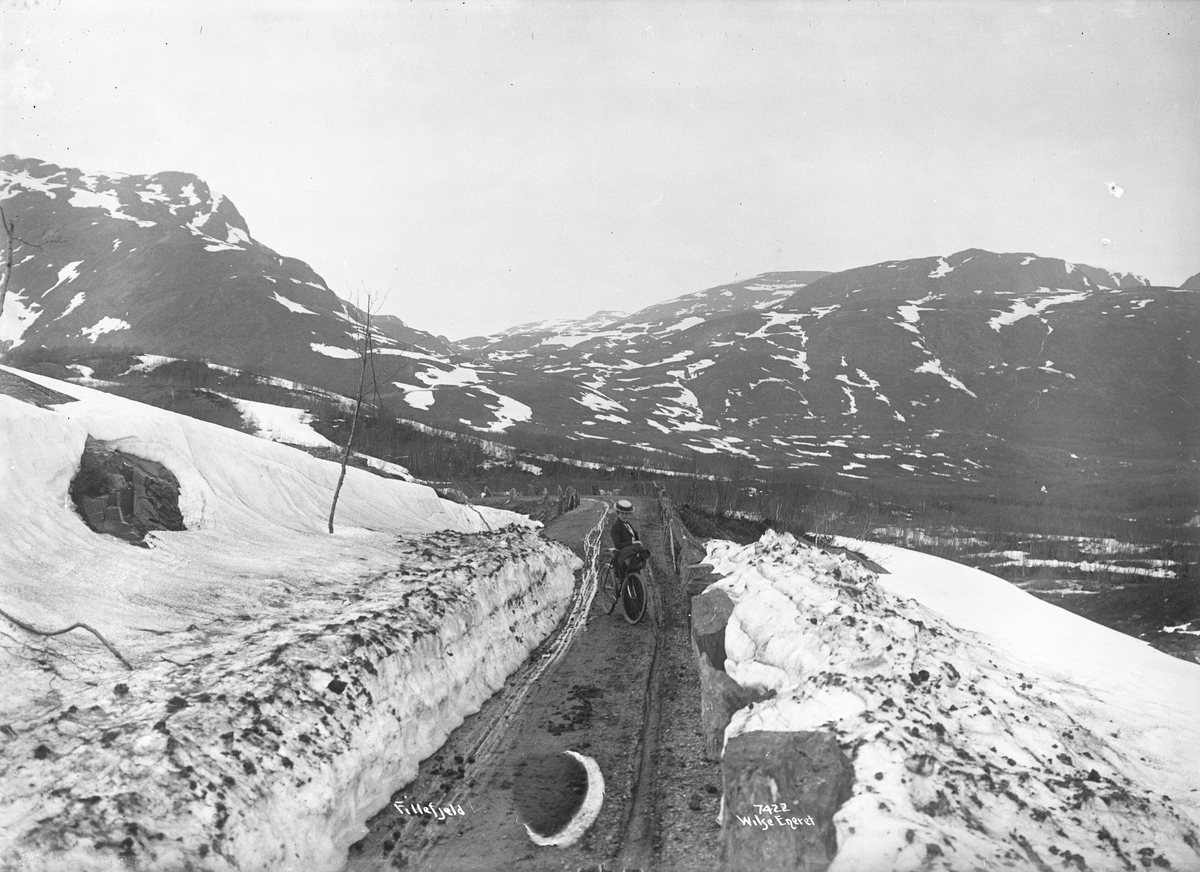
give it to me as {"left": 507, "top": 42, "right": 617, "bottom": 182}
{"left": 721, "top": 732, "right": 854, "bottom": 872}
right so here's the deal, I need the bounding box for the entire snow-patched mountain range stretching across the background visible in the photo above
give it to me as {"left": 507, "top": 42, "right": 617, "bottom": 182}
{"left": 0, "top": 157, "right": 1200, "bottom": 501}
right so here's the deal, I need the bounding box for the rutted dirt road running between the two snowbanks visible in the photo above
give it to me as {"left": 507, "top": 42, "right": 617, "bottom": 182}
{"left": 346, "top": 498, "right": 720, "bottom": 872}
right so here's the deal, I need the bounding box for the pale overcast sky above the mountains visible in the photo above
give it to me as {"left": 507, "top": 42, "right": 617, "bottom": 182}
{"left": 0, "top": 0, "right": 1200, "bottom": 338}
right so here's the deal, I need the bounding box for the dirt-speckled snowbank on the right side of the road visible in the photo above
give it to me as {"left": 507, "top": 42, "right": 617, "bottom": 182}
{"left": 708, "top": 531, "right": 1200, "bottom": 872}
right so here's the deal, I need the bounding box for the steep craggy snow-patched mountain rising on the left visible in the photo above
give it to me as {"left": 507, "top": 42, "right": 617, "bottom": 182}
{"left": 0, "top": 155, "right": 450, "bottom": 387}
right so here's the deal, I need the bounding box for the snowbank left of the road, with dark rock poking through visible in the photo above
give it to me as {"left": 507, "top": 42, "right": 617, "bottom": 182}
{"left": 0, "top": 368, "right": 578, "bottom": 872}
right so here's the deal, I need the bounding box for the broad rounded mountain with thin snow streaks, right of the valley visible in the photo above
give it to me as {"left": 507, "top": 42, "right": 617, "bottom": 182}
{"left": 456, "top": 249, "right": 1200, "bottom": 498}
